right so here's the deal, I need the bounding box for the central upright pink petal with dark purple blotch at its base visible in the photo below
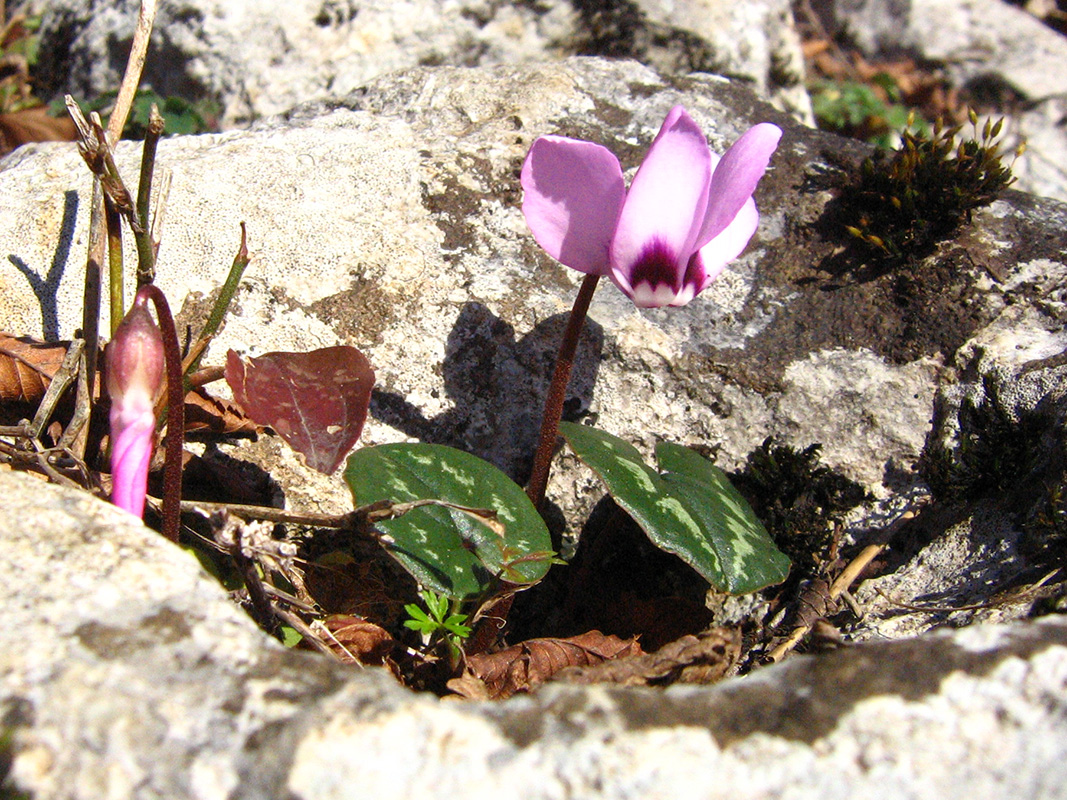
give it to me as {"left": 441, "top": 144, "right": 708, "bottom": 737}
{"left": 610, "top": 106, "right": 712, "bottom": 298}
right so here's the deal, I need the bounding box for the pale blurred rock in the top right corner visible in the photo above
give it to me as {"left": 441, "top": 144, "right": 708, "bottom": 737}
{"left": 819, "top": 0, "right": 1067, "bottom": 201}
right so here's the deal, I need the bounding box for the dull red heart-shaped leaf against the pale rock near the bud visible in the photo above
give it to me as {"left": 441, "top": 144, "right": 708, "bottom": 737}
{"left": 226, "top": 346, "right": 375, "bottom": 475}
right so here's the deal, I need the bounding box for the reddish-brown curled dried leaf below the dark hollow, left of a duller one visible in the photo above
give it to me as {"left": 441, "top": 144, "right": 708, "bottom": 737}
{"left": 448, "top": 630, "right": 642, "bottom": 700}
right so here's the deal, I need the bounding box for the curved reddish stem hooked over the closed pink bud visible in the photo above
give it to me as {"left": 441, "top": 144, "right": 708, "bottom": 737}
{"left": 137, "top": 284, "right": 186, "bottom": 542}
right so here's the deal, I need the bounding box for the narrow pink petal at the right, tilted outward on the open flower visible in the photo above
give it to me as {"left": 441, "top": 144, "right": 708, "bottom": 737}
{"left": 697, "top": 123, "right": 782, "bottom": 246}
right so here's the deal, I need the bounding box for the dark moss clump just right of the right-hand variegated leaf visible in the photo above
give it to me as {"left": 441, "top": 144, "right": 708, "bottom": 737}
{"left": 731, "top": 437, "right": 866, "bottom": 577}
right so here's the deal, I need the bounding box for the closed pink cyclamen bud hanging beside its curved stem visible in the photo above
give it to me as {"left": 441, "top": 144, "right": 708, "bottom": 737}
{"left": 105, "top": 295, "right": 163, "bottom": 516}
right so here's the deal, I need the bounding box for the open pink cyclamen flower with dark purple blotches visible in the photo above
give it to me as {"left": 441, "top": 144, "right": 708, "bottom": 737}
{"left": 522, "top": 106, "right": 782, "bottom": 307}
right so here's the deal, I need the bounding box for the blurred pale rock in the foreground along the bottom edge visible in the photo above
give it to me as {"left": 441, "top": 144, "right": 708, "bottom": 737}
{"left": 0, "top": 471, "right": 1067, "bottom": 800}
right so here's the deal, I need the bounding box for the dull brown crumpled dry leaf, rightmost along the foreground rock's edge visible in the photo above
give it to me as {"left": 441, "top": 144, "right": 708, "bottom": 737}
{"left": 552, "top": 627, "right": 740, "bottom": 686}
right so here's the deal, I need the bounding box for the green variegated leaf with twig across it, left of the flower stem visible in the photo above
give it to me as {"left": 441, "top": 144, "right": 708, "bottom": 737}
{"left": 345, "top": 444, "right": 554, "bottom": 599}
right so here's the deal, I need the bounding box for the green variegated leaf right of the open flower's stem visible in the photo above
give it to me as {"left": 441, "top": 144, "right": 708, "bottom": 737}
{"left": 559, "top": 422, "right": 790, "bottom": 594}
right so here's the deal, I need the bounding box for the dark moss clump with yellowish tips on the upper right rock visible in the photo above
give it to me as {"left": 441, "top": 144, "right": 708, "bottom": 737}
{"left": 841, "top": 111, "right": 1021, "bottom": 266}
